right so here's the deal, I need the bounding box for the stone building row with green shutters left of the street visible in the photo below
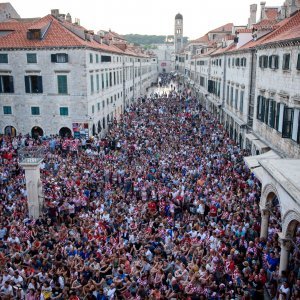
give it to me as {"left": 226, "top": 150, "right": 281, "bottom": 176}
{"left": 0, "top": 10, "right": 157, "bottom": 136}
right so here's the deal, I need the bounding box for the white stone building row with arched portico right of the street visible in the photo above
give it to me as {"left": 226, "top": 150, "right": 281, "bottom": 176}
{"left": 177, "top": 0, "right": 300, "bottom": 272}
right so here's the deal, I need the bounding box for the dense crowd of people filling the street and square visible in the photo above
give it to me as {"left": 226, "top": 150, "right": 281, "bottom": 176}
{"left": 0, "top": 78, "right": 300, "bottom": 300}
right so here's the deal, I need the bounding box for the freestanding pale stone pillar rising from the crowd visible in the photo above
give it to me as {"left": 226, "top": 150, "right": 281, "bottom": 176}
{"left": 20, "top": 160, "right": 43, "bottom": 219}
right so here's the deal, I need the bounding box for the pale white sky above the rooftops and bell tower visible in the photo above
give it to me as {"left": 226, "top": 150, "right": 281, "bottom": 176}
{"left": 9, "top": 0, "right": 284, "bottom": 39}
